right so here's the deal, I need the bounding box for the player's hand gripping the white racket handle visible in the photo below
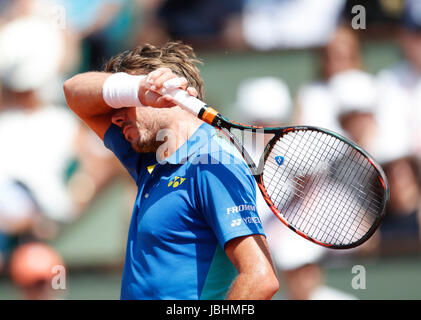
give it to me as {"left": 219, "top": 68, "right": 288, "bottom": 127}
{"left": 139, "top": 68, "right": 197, "bottom": 108}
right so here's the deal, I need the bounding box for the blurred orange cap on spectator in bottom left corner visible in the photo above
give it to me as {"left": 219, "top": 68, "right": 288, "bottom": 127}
{"left": 10, "top": 242, "right": 64, "bottom": 287}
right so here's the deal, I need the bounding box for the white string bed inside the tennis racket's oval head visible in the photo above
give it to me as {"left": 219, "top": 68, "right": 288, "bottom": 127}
{"left": 263, "top": 131, "right": 384, "bottom": 245}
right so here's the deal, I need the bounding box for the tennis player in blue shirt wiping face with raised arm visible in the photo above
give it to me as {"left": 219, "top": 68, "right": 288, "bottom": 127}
{"left": 64, "top": 42, "right": 279, "bottom": 300}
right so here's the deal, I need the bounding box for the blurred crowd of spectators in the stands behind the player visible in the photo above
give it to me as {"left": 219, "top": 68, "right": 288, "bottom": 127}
{"left": 0, "top": 0, "right": 421, "bottom": 299}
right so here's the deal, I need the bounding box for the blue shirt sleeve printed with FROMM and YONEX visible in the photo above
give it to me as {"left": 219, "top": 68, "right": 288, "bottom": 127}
{"left": 196, "top": 156, "right": 264, "bottom": 248}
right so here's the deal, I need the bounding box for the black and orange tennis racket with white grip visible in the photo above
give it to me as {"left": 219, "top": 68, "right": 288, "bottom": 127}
{"left": 160, "top": 89, "right": 389, "bottom": 249}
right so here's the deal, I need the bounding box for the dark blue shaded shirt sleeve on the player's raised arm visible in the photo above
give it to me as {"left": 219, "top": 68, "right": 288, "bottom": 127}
{"left": 104, "top": 124, "right": 141, "bottom": 182}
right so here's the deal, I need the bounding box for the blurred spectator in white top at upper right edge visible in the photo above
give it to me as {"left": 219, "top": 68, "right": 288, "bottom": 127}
{"left": 378, "top": 0, "right": 421, "bottom": 161}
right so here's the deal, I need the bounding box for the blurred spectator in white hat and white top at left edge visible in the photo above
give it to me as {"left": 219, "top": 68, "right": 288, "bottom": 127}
{"left": 0, "top": 18, "right": 73, "bottom": 228}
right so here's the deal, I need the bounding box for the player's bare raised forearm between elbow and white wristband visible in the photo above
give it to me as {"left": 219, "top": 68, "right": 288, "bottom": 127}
{"left": 63, "top": 72, "right": 113, "bottom": 118}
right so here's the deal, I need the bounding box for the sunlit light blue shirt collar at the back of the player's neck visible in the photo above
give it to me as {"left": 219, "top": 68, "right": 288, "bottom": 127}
{"left": 158, "top": 123, "right": 216, "bottom": 165}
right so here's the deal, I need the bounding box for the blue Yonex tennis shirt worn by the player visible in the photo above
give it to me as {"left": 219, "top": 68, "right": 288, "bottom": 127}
{"left": 104, "top": 124, "right": 264, "bottom": 300}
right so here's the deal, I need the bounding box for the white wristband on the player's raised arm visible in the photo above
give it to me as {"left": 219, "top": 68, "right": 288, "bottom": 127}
{"left": 102, "top": 72, "right": 146, "bottom": 109}
